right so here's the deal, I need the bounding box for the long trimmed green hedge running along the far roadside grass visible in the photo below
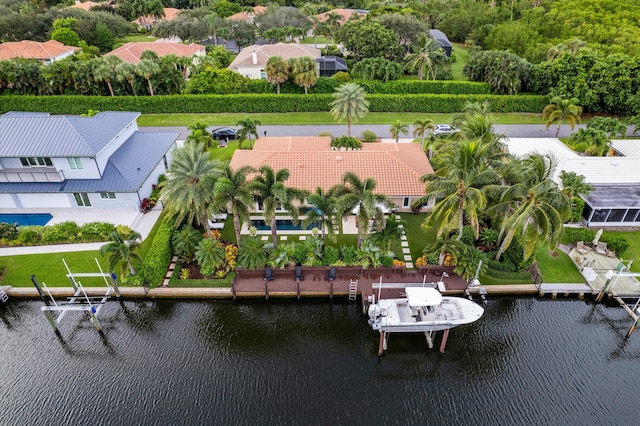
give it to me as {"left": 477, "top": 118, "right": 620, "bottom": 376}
{"left": 0, "top": 94, "right": 548, "bottom": 114}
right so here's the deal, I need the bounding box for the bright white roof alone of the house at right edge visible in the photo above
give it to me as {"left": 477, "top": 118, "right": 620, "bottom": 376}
{"left": 507, "top": 138, "right": 640, "bottom": 185}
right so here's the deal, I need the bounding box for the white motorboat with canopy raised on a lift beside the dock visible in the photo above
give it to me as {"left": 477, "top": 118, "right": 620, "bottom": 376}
{"left": 369, "top": 287, "right": 484, "bottom": 333}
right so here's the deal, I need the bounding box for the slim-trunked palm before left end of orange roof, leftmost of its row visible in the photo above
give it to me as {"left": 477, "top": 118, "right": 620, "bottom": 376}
{"left": 213, "top": 164, "right": 255, "bottom": 248}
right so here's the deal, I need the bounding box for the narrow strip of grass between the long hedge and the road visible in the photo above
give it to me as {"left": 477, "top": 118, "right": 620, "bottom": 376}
{"left": 138, "top": 112, "right": 544, "bottom": 130}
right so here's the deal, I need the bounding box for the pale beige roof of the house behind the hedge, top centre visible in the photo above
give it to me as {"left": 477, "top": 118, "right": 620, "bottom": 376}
{"left": 229, "top": 43, "right": 321, "bottom": 71}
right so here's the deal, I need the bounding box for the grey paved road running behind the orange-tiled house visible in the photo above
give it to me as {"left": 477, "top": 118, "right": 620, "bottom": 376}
{"left": 140, "top": 124, "right": 583, "bottom": 139}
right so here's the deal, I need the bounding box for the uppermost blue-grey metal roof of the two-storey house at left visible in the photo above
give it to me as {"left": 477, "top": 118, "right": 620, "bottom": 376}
{"left": 0, "top": 111, "right": 140, "bottom": 158}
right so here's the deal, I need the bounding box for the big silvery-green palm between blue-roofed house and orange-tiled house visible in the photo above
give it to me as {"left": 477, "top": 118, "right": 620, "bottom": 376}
{"left": 161, "top": 143, "right": 220, "bottom": 227}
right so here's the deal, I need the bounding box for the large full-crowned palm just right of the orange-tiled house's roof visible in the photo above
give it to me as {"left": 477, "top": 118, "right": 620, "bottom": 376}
{"left": 413, "top": 140, "right": 497, "bottom": 241}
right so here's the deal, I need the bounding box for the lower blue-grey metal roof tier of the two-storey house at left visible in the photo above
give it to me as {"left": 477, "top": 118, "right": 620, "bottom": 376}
{"left": 0, "top": 132, "right": 178, "bottom": 193}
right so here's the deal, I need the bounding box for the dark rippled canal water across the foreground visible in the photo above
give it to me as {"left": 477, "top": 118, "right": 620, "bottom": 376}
{"left": 0, "top": 298, "right": 640, "bottom": 426}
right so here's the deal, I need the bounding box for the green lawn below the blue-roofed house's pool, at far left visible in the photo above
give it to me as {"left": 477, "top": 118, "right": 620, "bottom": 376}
{"left": 0, "top": 251, "right": 108, "bottom": 287}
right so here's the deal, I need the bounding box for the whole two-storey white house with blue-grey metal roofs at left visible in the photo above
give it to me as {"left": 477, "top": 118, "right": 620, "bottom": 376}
{"left": 0, "top": 111, "right": 178, "bottom": 211}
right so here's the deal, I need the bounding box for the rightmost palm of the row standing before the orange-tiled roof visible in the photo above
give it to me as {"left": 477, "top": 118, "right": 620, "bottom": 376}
{"left": 336, "top": 172, "right": 393, "bottom": 247}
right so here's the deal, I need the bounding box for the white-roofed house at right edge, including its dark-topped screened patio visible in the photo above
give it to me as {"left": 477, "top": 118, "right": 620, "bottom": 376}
{"left": 506, "top": 138, "right": 640, "bottom": 226}
